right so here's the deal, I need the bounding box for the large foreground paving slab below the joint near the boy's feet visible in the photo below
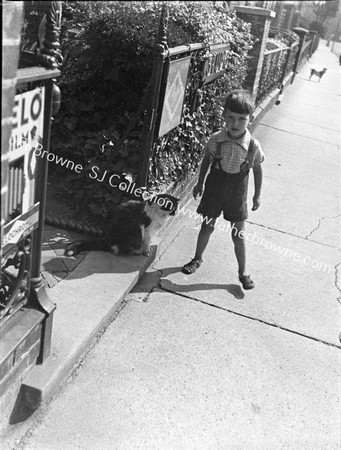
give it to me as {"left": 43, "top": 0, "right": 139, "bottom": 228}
{"left": 15, "top": 291, "right": 340, "bottom": 450}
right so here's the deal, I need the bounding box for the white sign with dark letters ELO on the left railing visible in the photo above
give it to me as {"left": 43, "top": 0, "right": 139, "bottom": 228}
{"left": 8, "top": 87, "right": 45, "bottom": 214}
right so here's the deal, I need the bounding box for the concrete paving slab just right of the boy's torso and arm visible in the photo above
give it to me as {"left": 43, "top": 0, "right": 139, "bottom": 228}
{"left": 249, "top": 120, "right": 341, "bottom": 239}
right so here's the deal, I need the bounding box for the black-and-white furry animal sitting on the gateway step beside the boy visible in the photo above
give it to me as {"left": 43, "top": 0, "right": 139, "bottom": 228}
{"left": 64, "top": 194, "right": 180, "bottom": 256}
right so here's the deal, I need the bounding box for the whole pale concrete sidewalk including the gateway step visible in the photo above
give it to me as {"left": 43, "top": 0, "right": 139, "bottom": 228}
{"left": 5, "top": 42, "right": 341, "bottom": 450}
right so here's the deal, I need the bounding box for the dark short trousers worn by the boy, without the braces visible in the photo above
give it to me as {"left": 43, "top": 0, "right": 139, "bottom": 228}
{"left": 197, "top": 168, "right": 249, "bottom": 222}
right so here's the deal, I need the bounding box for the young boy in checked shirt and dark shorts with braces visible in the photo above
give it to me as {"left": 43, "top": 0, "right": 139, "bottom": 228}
{"left": 182, "top": 90, "right": 265, "bottom": 289}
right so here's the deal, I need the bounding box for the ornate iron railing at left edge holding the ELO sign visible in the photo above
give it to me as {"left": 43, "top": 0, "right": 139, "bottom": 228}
{"left": 0, "top": 1, "right": 61, "bottom": 356}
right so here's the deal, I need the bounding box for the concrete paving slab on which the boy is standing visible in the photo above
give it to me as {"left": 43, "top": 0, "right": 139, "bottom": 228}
{"left": 153, "top": 222, "right": 341, "bottom": 346}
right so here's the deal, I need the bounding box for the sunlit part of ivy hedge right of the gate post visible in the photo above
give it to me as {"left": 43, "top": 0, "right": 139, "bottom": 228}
{"left": 149, "top": 2, "right": 252, "bottom": 190}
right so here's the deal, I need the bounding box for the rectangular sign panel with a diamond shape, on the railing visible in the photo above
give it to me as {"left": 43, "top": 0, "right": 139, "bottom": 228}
{"left": 159, "top": 56, "right": 191, "bottom": 137}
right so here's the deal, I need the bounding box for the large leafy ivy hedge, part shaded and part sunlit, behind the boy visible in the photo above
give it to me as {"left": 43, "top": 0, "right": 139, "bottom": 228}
{"left": 50, "top": 1, "right": 253, "bottom": 217}
